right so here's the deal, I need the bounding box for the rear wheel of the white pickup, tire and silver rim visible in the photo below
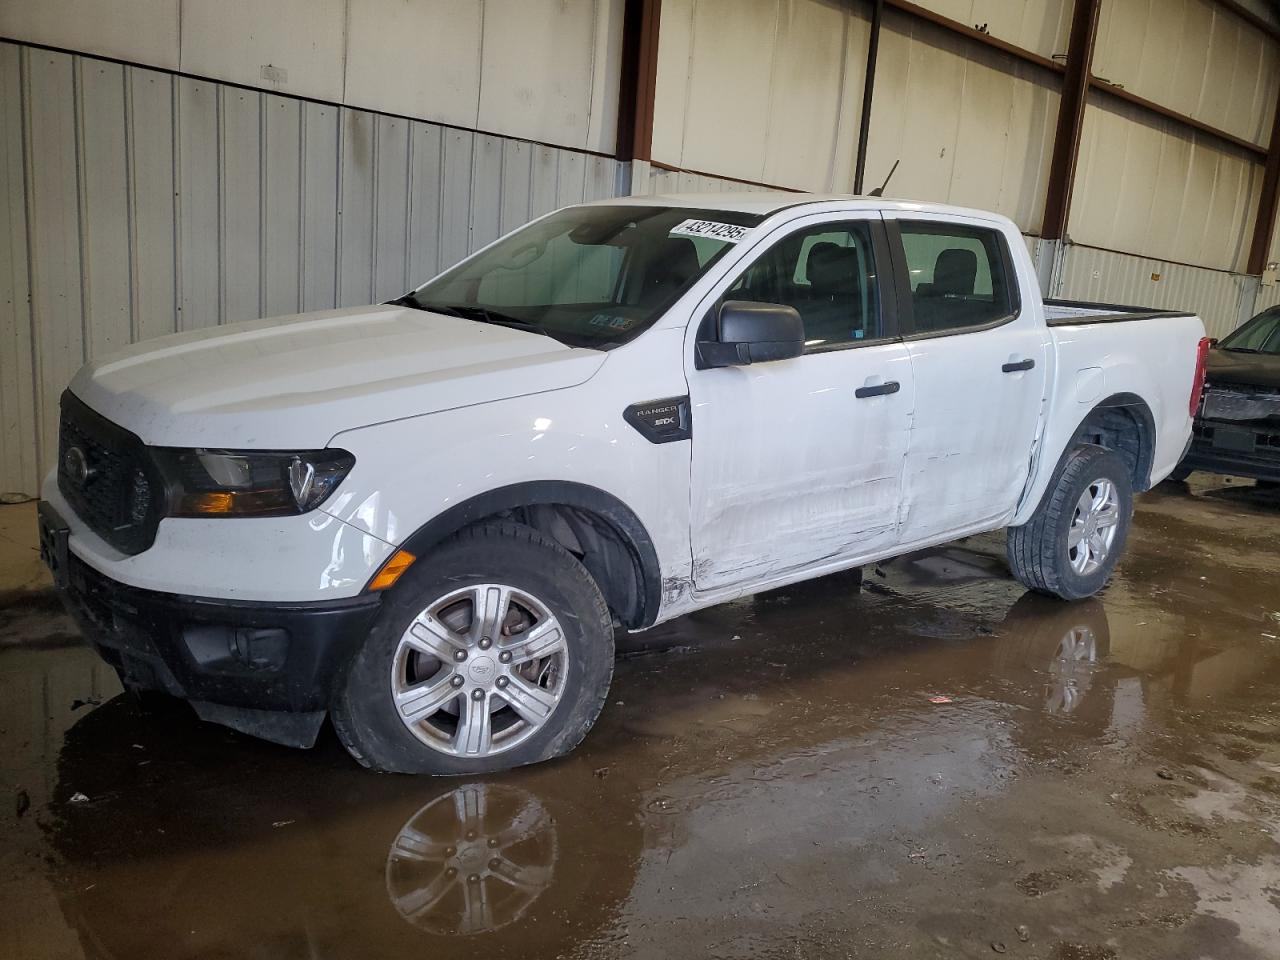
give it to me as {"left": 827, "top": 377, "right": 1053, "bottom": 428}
{"left": 1006, "top": 444, "right": 1133, "bottom": 600}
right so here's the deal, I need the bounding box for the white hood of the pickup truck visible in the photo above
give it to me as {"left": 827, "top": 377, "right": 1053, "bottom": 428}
{"left": 70, "top": 305, "right": 605, "bottom": 449}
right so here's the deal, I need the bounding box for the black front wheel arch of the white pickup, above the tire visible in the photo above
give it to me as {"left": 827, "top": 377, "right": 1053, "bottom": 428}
{"left": 384, "top": 480, "right": 662, "bottom": 628}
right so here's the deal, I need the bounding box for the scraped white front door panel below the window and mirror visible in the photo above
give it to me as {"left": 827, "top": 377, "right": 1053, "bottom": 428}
{"left": 691, "top": 342, "right": 914, "bottom": 591}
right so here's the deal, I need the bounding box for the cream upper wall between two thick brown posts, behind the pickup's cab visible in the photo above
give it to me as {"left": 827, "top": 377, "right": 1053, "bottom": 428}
{"left": 653, "top": 0, "right": 1069, "bottom": 232}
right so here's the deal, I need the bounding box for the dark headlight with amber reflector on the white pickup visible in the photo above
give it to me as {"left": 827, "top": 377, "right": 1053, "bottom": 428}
{"left": 155, "top": 448, "right": 356, "bottom": 517}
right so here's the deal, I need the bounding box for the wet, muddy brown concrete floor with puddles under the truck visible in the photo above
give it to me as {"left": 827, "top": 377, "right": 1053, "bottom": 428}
{"left": 0, "top": 475, "right": 1280, "bottom": 960}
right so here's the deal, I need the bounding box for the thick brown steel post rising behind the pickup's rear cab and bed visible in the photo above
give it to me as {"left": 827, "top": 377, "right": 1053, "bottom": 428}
{"left": 1041, "top": 0, "right": 1100, "bottom": 239}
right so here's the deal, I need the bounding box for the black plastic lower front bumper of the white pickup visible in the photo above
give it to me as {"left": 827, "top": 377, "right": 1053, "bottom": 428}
{"left": 60, "top": 556, "right": 380, "bottom": 740}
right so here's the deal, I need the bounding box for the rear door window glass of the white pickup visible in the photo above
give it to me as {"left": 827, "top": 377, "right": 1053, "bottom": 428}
{"left": 899, "top": 220, "right": 1016, "bottom": 333}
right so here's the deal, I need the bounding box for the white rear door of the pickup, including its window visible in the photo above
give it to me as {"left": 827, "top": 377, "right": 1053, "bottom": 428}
{"left": 886, "top": 212, "right": 1050, "bottom": 547}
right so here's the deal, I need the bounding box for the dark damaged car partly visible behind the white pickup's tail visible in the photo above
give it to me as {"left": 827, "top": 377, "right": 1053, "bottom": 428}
{"left": 1174, "top": 306, "right": 1280, "bottom": 485}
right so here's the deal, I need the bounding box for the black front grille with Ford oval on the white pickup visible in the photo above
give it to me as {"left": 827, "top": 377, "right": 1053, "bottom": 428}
{"left": 58, "top": 393, "right": 164, "bottom": 554}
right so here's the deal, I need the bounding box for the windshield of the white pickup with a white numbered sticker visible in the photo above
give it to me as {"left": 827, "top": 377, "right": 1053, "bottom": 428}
{"left": 396, "top": 206, "right": 763, "bottom": 349}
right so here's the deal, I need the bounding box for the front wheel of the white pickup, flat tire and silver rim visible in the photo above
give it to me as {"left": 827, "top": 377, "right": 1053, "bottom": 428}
{"left": 332, "top": 522, "right": 613, "bottom": 774}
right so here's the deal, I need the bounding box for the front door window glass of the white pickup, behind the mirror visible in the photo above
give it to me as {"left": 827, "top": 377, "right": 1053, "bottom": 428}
{"left": 723, "top": 221, "right": 882, "bottom": 352}
